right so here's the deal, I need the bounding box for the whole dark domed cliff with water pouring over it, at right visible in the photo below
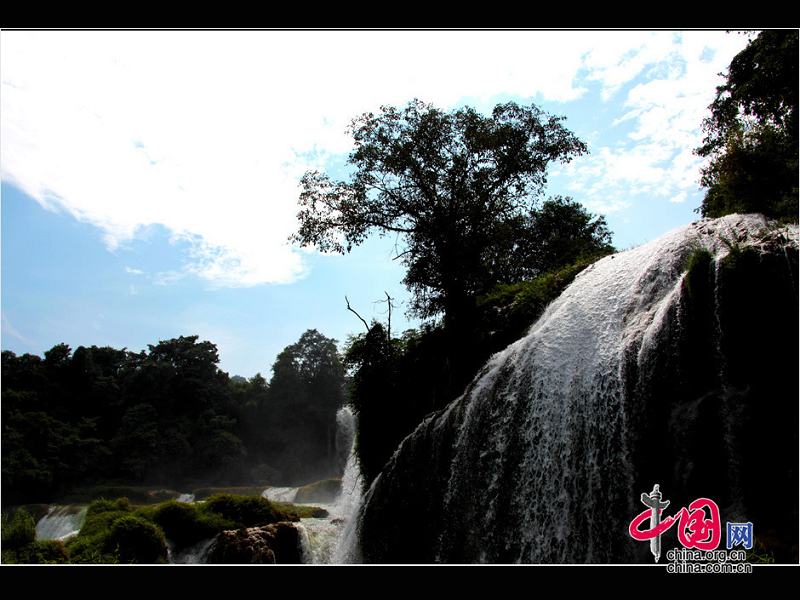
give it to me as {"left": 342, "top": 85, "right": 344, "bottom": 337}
{"left": 359, "top": 215, "right": 798, "bottom": 563}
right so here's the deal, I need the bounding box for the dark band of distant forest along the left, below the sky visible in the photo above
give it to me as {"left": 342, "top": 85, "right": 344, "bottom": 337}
{"left": 2, "top": 330, "right": 344, "bottom": 505}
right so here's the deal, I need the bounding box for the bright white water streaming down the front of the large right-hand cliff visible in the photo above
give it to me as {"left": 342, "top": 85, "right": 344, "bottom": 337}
{"left": 358, "top": 215, "right": 797, "bottom": 563}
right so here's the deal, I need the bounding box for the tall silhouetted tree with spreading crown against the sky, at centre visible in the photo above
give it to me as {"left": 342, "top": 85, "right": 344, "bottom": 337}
{"left": 293, "top": 100, "right": 586, "bottom": 330}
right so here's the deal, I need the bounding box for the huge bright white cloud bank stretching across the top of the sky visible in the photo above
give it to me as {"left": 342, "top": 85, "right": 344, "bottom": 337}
{"left": 0, "top": 31, "right": 746, "bottom": 286}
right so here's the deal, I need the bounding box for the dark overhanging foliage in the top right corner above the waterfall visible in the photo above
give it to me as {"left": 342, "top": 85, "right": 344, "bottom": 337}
{"left": 695, "top": 29, "right": 798, "bottom": 222}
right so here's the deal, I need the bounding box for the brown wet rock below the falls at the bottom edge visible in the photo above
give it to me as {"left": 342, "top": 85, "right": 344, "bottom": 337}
{"left": 207, "top": 522, "right": 303, "bottom": 564}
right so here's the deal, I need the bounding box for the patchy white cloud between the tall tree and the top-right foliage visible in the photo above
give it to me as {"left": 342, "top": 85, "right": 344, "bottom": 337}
{"left": 564, "top": 31, "right": 747, "bottom": 212}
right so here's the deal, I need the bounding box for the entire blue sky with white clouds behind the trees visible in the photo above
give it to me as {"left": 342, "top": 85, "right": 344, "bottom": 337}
{"left": 0, "top": 31, "right": 748, "bottom": 376}
